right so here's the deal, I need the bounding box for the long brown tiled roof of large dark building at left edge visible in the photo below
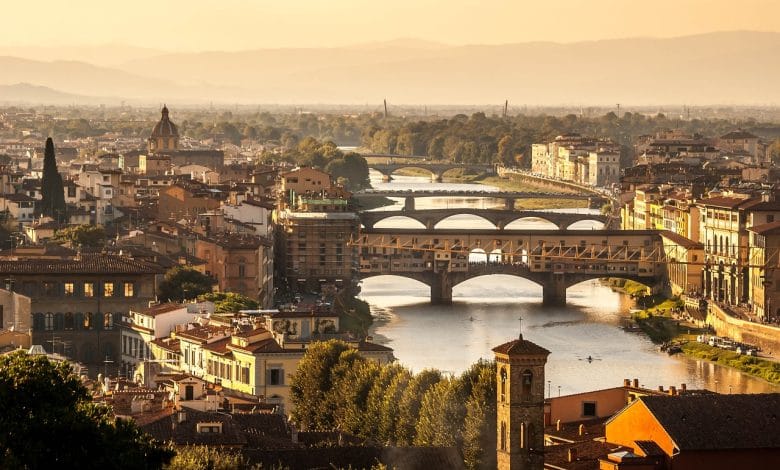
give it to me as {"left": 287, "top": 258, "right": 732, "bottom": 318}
{"left": 0, "top": 254, "right": 165, "bottom": 274}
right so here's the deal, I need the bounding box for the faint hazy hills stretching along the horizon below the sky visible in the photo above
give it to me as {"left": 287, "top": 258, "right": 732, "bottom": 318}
{"left": 0, "top": 31, "right": 780, "bottom": 106}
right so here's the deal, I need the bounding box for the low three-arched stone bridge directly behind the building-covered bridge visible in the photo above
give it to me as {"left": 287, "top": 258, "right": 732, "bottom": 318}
{"left": 360, "top": 208, "right": 609, "bottom": 230}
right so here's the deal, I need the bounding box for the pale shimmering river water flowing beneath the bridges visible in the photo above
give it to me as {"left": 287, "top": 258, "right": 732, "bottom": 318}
{"left": 361, "top": 172, "right": 780, "bottom": 396}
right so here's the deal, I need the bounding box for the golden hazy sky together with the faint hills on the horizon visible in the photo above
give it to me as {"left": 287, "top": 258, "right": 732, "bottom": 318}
{"left": 0, "top": 0, "right": 780, "bottom": 106}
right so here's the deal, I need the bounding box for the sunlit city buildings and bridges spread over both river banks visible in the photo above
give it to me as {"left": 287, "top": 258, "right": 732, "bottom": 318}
{"left": 0, "top": 106, "right": 780, "bottom": 470}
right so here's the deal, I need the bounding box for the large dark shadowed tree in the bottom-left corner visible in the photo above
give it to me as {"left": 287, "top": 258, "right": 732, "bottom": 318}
{"left": 0, "top": 352, "right": 173, "bottom": 469}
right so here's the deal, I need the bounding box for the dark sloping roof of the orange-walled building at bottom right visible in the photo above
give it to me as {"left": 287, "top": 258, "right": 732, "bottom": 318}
{"left": 636, "top": 393, "right": 780, "bottom": 451}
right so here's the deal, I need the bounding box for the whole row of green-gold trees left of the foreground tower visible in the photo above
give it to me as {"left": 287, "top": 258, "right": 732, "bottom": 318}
{"left": 292, "top": 341, "right": 496, "bottom": 469}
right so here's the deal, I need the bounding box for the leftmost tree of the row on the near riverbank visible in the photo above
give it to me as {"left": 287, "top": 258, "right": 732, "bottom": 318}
{"left": 290, "top": 341, "right": 350, "bottom": 430}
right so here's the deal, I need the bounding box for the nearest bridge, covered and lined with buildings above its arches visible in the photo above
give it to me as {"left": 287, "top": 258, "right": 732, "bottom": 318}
{"left": 351, "top": 229, "right": 668, "bottom": 305}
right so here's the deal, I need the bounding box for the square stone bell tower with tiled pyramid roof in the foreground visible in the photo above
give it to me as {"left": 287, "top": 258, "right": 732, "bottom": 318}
{"left": 493, "top": 334, "right": 550, "bottom": 470}
